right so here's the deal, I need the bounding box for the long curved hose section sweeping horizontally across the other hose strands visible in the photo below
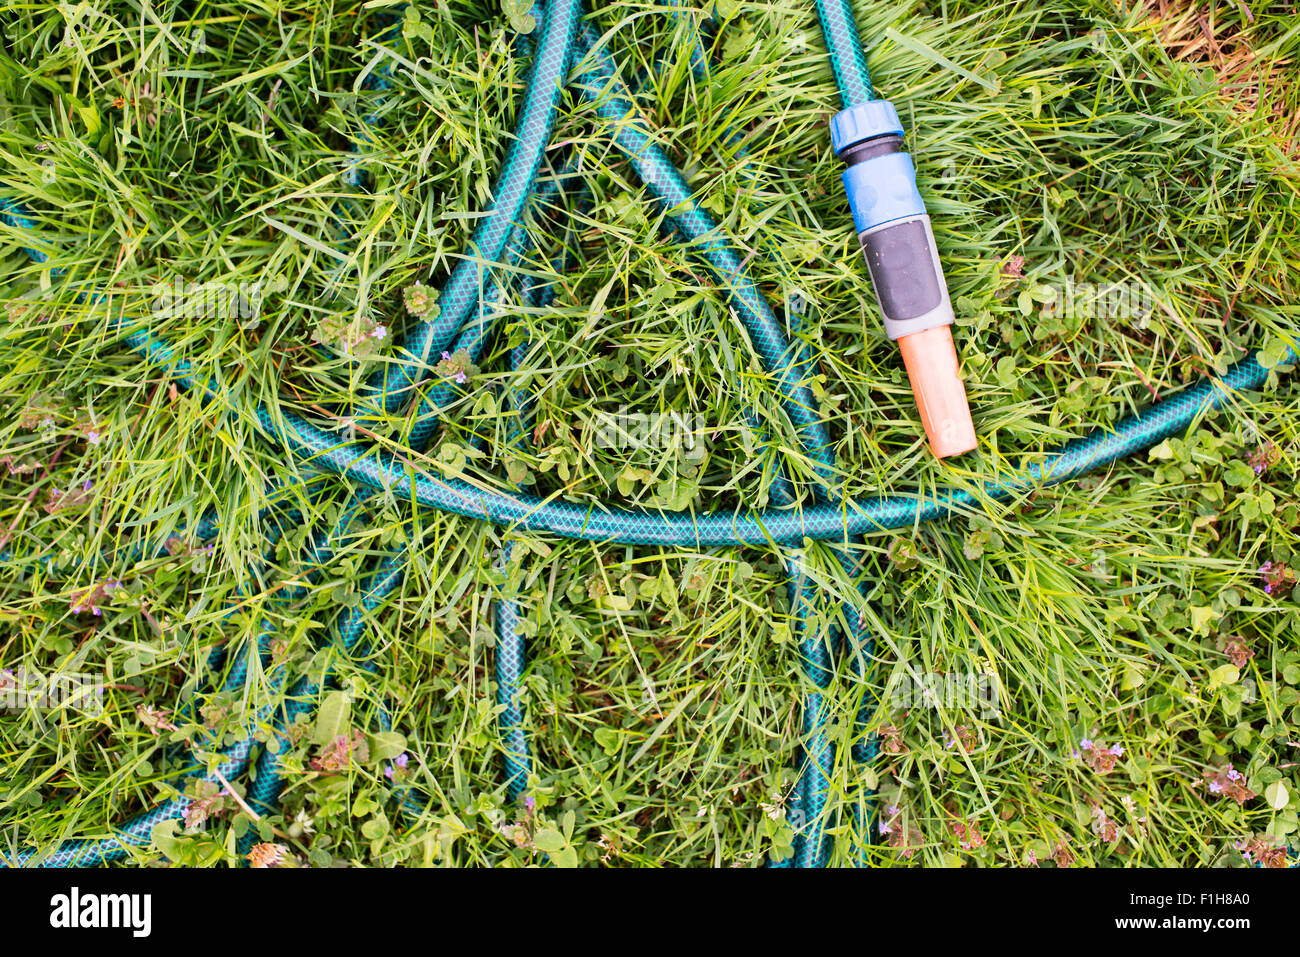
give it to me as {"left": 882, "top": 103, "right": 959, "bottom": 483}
{"left": 63, "top": 332, "right": 1279, "bottom": 549}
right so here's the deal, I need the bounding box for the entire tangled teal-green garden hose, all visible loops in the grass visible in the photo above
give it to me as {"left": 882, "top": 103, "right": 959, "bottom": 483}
{"left": 0, "top": 0, "right": 1296, "bottom": 865}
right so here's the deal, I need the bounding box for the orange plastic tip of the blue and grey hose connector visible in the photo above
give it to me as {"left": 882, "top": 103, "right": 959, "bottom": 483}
{"left": 898, "top": 325, "right": 975, "bottom": 459}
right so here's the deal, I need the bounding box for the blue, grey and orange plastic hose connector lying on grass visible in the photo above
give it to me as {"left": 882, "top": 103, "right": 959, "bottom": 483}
{"left": 831, "top": 100, "right": 975, "bottom": 459}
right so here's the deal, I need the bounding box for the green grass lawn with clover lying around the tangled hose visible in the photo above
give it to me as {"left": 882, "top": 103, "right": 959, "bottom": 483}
{"left": 0, "top": 0, "right": 1300, "bottom": 866}
